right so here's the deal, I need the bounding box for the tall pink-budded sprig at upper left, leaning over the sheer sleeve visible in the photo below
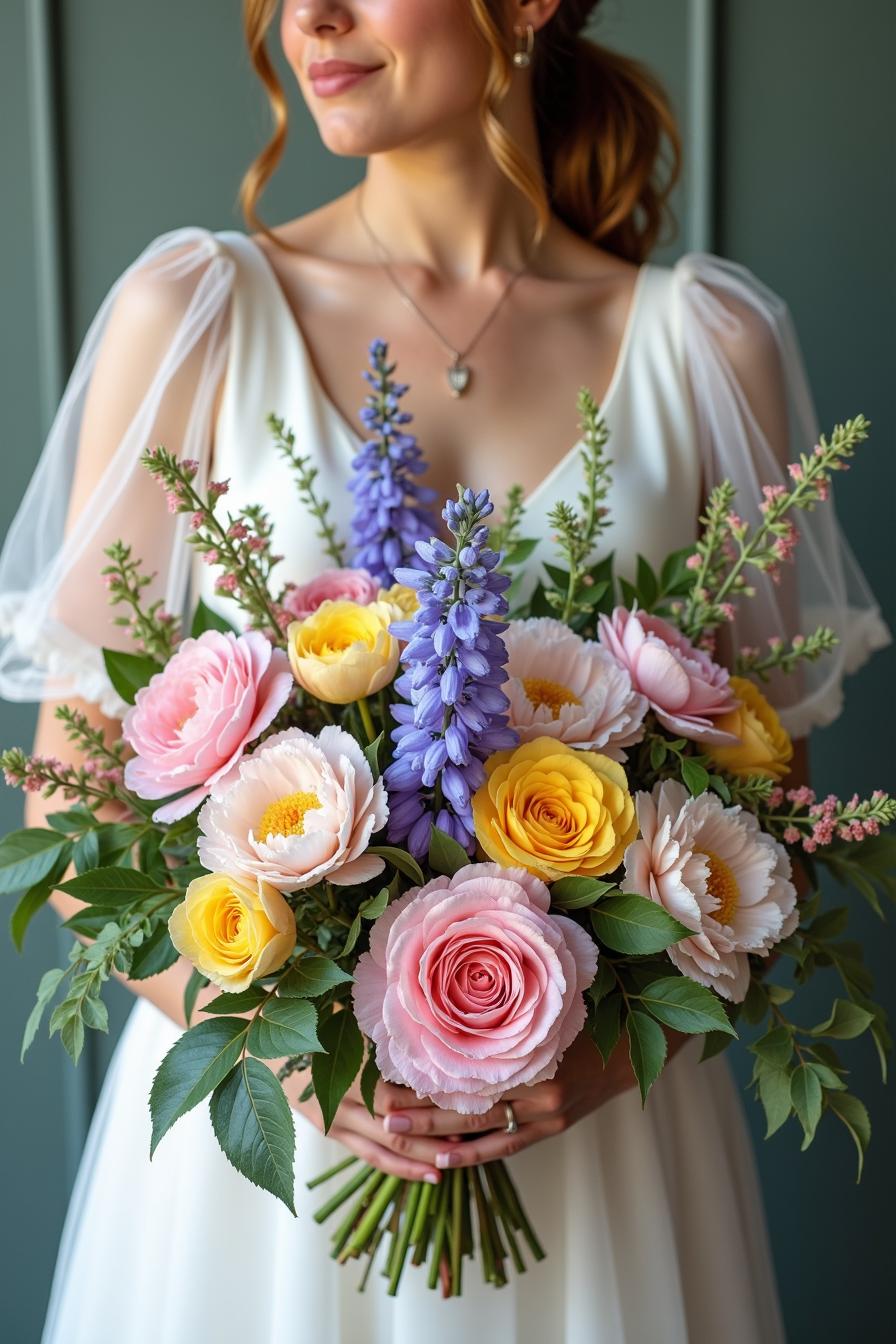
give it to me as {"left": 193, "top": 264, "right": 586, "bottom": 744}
{"left": 141, "top": 445, "right": 289, "bottom": 644}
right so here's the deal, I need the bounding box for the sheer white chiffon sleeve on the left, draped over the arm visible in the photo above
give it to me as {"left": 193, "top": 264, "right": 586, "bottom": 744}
{"left": 0, "top": 227, "right": 234, "bottom": 716}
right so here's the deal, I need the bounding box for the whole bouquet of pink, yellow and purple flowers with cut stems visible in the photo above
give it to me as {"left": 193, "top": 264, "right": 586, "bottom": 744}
{"left": 0, "top": 341, "right": 896, "bottom": 1293}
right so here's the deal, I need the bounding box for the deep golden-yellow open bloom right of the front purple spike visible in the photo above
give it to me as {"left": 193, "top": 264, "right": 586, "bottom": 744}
{"left": 473, "top": 738, "right": 638, "bottom": 882}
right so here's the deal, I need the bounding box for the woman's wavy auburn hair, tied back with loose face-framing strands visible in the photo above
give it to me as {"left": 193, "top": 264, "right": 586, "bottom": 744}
{"left": 239, "top": 0, "right": 681, "bottom": 263}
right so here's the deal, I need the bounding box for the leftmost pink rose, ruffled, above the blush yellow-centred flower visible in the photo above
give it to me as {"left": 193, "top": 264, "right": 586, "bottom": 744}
{"left": 121, "top": 630, "right": 293, "bottom": 821}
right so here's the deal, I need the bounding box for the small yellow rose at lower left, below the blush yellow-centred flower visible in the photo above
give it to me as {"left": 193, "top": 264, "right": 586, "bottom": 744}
{"left": 168, "top": 872, "right": 296, "bottom": 993}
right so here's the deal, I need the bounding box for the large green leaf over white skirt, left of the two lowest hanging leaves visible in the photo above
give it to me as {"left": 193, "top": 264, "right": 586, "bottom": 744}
{"left": 149, "top": 1017, "right": 248, "bottom": 1157}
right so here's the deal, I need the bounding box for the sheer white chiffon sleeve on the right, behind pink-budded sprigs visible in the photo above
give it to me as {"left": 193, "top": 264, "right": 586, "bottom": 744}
{"left": 674, "top": 253, "right": 892, "bottom": 737}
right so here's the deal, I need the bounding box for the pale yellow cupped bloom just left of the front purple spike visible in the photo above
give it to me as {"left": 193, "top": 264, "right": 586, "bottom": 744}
{"left": 286, "top": 599, "right": 399, "bottom": 704}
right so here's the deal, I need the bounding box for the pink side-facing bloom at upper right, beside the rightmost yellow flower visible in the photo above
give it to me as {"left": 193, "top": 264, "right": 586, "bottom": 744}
{"left": 598, "top": 606, "right": 737, "bottom": 746}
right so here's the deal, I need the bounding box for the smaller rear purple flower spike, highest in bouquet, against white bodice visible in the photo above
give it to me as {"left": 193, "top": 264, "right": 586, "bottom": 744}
{"left": 349, "top": 340, "right": 435, "bottom": 587}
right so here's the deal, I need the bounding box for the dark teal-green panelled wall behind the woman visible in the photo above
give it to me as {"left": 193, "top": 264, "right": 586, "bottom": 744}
{"left": 0, "top": 0, "right": 896, "bottom": 1344}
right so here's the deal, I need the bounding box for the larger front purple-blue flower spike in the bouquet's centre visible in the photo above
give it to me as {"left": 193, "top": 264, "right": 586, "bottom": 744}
{"left": 384, "top": 489, "right": 519, "bottom": 859}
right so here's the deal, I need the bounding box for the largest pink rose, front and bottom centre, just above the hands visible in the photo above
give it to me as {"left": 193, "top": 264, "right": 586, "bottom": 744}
{"left": 352, "top": 863, "right": 598, "bottom": 1114}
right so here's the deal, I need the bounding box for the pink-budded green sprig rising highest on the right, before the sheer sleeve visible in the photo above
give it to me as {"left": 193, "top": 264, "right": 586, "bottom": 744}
{"left": 678, "top": 415, "right": 869, "bottom": 642}
